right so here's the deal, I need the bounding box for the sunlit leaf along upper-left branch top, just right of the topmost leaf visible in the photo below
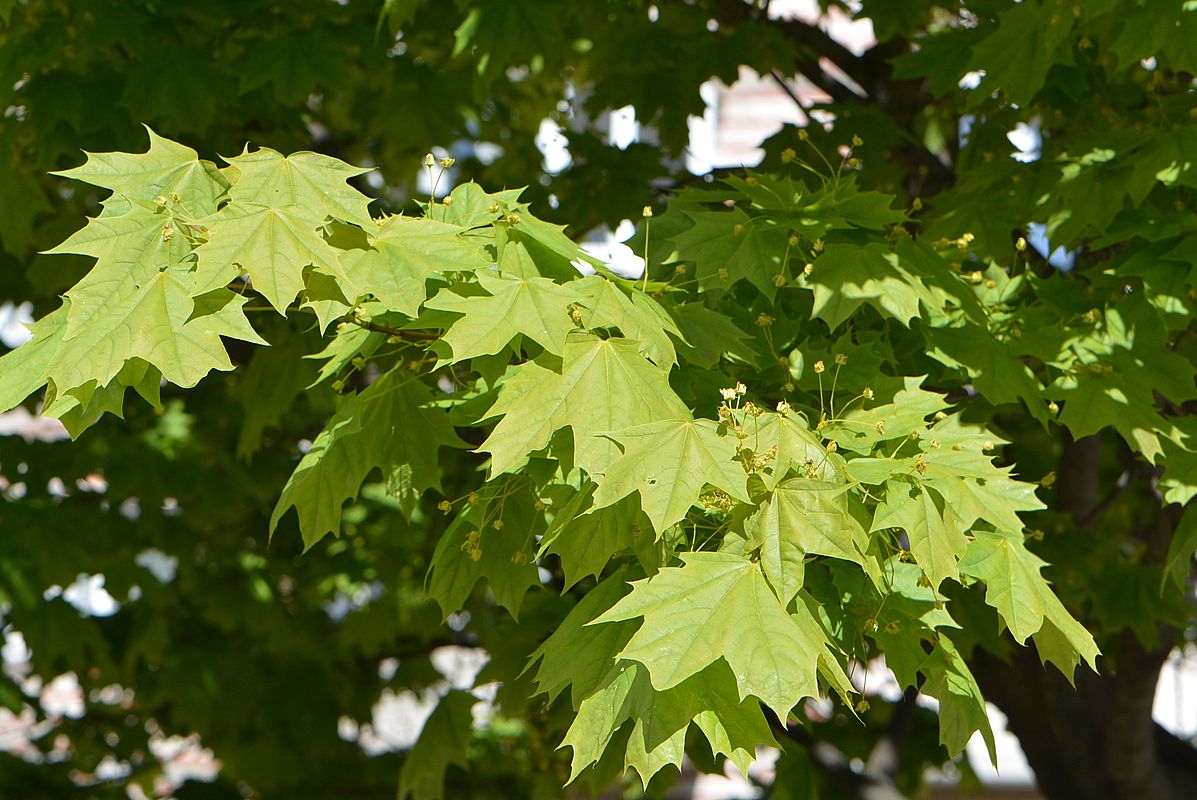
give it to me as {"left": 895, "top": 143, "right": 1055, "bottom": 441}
{"left": 225, "top": 147, "right": 372, "bottom": 230}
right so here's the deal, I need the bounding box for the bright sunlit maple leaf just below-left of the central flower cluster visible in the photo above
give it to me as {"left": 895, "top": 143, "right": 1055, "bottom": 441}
{"left": 595, "top": 419, "right": 748, "bottom": 534}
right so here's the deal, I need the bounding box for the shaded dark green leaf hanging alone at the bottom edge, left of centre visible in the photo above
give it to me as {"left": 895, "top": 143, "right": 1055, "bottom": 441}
{"left": 399, "top": 690, "right": 478, "bottom": 800}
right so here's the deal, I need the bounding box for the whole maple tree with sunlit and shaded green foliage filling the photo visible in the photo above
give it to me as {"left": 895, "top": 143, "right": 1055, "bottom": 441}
{"left": 0, "top": 0, "right": 1197, "bottom": 799}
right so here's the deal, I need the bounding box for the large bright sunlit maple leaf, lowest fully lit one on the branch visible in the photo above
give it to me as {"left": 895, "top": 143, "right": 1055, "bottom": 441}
{"left": 593, "top": 552, "right": 847, "bottom": 719}
